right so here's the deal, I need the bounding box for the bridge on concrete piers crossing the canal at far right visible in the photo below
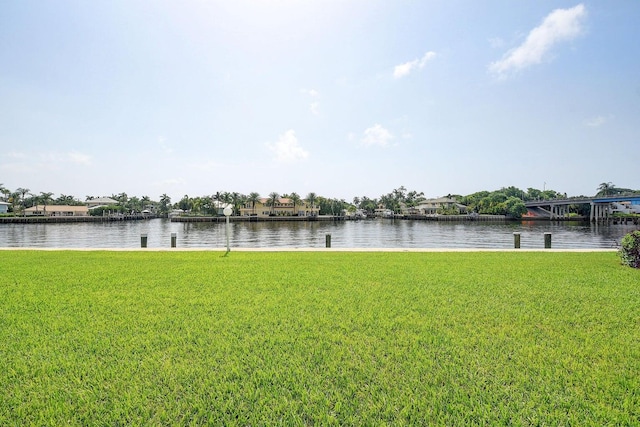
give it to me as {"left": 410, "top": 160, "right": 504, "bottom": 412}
{"left": 524, "top": 194, "right": 640, "bottom": 222}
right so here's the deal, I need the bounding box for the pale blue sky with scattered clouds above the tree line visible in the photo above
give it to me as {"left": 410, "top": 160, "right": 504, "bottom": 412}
{"left": 0, "top": 0, "right": 640, "bottom": 201}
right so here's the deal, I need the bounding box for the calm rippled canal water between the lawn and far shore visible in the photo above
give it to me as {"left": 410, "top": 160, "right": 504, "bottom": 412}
{"left": 0, "top": 219, "right": 637, "bottom": 249}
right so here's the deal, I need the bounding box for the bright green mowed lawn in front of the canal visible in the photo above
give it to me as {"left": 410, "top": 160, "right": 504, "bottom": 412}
{"left": 0, "top": 251, "right": 640, "bottom": 426}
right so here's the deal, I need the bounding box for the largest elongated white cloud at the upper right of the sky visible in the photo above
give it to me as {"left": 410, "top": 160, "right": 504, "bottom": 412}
{"left": 489, "top": 4, "right": 587, "bottom": 76}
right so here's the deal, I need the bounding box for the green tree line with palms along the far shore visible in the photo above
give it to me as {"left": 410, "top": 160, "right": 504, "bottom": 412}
{"left": 0, "top": 182, "right": 640, "bottom": 218}
